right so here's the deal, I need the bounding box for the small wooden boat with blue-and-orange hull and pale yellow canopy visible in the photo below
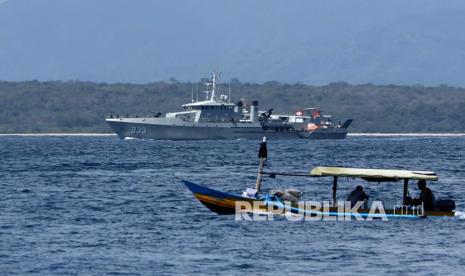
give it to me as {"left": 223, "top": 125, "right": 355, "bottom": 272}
{"left": 183, "top": 139, "right": 455, "bottom": 218}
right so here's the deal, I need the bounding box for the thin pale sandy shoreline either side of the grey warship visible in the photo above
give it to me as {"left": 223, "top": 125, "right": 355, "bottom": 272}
{"left": 0, "top": 133, "right": 465, "bottom": 137}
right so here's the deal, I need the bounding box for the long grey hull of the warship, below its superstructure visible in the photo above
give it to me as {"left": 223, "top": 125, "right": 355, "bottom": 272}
{"left": 106, "top": 118, "right": 347, "bottom": 140}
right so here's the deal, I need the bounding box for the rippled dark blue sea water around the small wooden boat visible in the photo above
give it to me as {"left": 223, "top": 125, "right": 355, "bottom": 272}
{"left": 0, "top": 136, "right": 465, "bottom": 275}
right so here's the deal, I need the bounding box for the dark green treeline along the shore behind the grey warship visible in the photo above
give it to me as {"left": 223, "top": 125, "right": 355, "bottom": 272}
{"left": 0, "top": 80, "right": 465, "bottom": 133}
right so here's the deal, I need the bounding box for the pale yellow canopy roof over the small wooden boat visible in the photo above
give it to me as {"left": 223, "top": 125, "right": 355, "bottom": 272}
{"left": 310, "top": 167, "right": 438, "bottom": 181}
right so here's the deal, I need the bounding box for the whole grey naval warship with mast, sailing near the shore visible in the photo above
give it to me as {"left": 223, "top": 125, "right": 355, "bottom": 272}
{"left": 106, "top": 72, "right": 352, "bottom": 140}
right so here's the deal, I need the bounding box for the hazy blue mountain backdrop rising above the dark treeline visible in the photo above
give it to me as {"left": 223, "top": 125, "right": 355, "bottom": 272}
{"left": 0, "top": 0, "right": 465, "bottom": 86}
